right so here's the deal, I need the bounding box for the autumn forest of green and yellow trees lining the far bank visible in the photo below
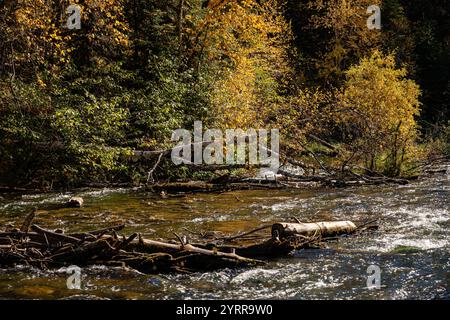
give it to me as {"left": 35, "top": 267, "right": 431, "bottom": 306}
{"left": 0, "top": 0, "right": 450, "bottom": 190}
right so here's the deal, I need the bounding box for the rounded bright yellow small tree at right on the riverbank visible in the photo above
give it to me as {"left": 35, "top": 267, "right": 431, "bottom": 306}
{"left": 336, "top": 51, "right": 420, "bottom": 175}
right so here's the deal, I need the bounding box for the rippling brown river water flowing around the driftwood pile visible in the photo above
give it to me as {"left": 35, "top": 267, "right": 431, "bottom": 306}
{"left": 0, "top": 171, "right": 450, "bottom": 299}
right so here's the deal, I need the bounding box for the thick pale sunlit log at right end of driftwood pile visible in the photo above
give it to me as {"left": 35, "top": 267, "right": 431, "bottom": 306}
{"left": 272, "top": 221, "right": 357, "bottom": 239}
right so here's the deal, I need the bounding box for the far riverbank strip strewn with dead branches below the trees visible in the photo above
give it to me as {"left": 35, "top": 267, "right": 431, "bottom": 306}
{"left": 0, "top": 156, "right": 450, "bottom": 195}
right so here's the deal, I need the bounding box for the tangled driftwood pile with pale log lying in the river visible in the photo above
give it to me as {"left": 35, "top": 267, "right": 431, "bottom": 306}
{"left": 0, "top": 213, "right": 372, "bottom": 273}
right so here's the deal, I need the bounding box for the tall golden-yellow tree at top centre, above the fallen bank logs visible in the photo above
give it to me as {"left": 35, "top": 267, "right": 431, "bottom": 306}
{"left": 187, "top": 0, "right": 291, "bottom": 128}
